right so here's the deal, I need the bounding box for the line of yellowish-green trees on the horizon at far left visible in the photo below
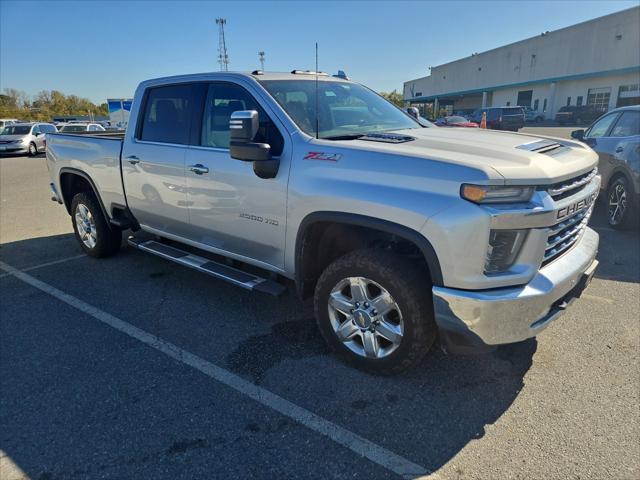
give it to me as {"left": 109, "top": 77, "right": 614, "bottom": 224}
{"left": 0, "top": 88, "right": 109, "bottom": 121}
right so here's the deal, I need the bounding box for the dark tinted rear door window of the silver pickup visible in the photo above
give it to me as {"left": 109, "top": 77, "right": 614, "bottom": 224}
{"left": 138, "top": 84, "right": 196, "bottom": 145}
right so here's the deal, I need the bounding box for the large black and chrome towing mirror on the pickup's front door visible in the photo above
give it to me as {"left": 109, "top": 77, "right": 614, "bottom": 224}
{"left": 229, "top": 110, "right": 280, "bottom": 178}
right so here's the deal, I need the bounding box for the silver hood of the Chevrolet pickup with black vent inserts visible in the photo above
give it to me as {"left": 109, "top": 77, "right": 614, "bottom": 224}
{"left": 337, "top": 127, "right": 598, "bottom": 185}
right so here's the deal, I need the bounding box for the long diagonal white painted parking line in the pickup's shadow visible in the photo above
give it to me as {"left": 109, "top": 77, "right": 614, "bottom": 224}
{"left": 0, "top": 261, "right": 434, "bottom": 478}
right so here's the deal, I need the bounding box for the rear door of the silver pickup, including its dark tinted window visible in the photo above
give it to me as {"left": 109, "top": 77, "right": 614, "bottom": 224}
{"left": 122, "top": 83, "right": 201, "bottom": 240}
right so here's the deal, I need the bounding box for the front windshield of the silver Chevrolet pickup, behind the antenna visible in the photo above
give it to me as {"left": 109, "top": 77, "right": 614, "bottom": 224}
{"left": 262, "top": 80, "right": 422, "bottom": 139}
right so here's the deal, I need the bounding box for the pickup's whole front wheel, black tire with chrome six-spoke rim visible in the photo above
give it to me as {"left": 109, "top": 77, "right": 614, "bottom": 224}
{"left": 314, "top": 250, "right": 437, "bottom": 374}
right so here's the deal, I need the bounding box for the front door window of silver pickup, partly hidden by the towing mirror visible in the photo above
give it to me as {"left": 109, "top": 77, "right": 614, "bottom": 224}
{"left": 200, "top": 82, "right": 284, "bottom": 156}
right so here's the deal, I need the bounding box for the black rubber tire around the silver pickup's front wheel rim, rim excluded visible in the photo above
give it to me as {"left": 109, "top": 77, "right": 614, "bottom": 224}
{"left": 314, "top": 250, "right": 438, "bottom": 375}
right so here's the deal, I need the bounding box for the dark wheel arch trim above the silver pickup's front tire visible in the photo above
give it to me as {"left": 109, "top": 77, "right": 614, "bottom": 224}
{"left": 295, "top": 211, "right": 443, "bottom": 292}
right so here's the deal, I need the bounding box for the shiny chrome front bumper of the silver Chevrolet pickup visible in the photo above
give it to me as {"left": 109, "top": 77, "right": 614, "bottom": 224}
{"left": 433, "top": 228, "right": 599, "bottom": 353}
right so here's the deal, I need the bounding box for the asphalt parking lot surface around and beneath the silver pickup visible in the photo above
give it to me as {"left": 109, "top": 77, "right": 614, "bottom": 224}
{"left": 0, "top": 136, "right": 640, "bottom": 480}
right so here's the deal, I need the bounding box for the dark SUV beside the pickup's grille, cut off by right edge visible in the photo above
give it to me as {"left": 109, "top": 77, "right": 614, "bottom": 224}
{"left": 571, "top": 105, "right": 640, "bottom": 228}
